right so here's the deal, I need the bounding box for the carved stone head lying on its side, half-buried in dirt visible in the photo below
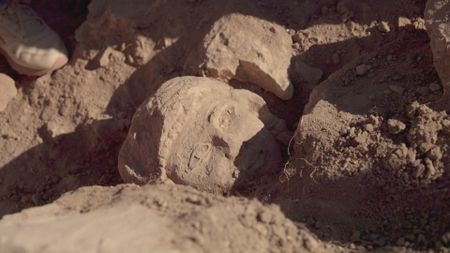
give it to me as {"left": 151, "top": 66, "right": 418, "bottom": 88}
{"left": 119, "top": 77, "right": 285, "bottom": 192}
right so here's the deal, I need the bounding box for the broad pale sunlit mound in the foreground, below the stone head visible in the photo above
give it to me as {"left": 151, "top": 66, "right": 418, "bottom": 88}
{"left": 0, "top": 185, "right": 326, "bottom": 253}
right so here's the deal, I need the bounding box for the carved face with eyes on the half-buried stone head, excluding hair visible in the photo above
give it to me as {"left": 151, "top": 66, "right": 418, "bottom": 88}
{"left": 167, "top": 97, "right": 281, "bottom": 191}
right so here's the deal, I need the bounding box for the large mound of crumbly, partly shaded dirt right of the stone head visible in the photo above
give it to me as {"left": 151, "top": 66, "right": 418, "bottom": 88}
{"left": 280, "top": 30, "right": 450, "bottom": 250}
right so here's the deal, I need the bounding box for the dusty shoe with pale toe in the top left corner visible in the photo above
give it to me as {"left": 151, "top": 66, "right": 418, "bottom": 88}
{"left": 0, "top": 3, "right": 68, "bottom": 76}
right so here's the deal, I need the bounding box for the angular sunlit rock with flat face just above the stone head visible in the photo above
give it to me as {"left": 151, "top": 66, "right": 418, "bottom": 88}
{"left": 186, "top": 14, "right": 293, "bottom": 100}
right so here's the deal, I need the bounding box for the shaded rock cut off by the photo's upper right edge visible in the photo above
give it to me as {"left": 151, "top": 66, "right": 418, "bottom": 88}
{"left": 425, "top": 0, "right": 450, "bottom": 97}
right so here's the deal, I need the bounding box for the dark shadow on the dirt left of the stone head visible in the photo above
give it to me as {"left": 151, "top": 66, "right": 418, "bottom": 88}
{"left": 0, "top": 120, "right": 128, "bottom": 217}
